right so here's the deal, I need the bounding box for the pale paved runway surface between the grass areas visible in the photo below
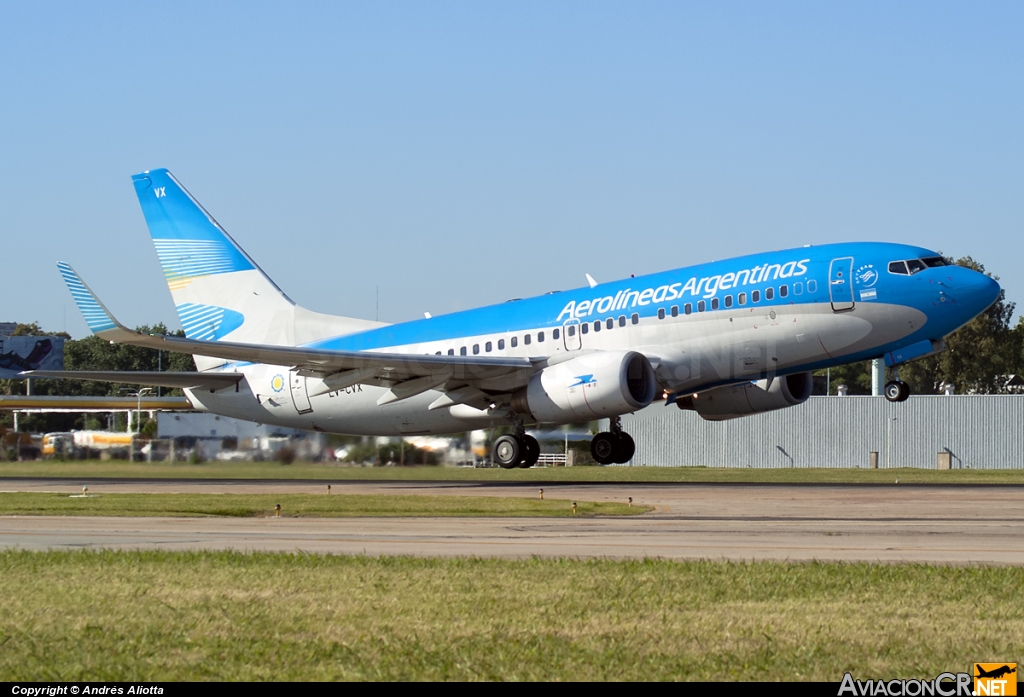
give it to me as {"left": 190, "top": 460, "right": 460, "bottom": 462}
{"left": 0, "top": 480, "right": 1024, "bottom": 565}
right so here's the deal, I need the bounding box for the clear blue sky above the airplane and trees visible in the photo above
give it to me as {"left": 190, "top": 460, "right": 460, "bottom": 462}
{"left": 0, "top": 0, "right": 1024, "bottom": 337}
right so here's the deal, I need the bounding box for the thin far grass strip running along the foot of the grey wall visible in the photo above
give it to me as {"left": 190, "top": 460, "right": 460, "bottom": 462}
{"left": 6, "top": 461, "right": 1024, "bottom": 484}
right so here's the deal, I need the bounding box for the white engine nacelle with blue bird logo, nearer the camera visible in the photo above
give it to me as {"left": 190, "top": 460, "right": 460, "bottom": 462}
{"left": 512, "top": 351, "right": 657, "bottom": 424}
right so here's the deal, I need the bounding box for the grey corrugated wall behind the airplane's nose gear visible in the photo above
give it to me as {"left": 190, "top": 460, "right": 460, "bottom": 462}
{"left": 623, "top": 395, "right": 1024, "bottom": 469}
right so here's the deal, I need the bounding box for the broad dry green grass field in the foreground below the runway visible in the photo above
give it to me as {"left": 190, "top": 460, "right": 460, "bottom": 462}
{"left": 0, "top": 552, "right": 1024, "bottom": 682}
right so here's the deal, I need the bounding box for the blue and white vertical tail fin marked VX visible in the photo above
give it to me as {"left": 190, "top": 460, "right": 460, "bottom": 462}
{"left": 132, "top": 169, "right": 380, "bottom": 369}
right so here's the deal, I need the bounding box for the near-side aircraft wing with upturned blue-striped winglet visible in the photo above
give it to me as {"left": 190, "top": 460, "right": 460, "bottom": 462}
{"left": 57, "top": 262, "right": 535, "bottom": 384}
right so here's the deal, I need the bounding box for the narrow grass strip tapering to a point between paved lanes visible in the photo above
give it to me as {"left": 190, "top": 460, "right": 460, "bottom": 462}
{"left": 0, "top": 492, "right": 650, "bottom": 518}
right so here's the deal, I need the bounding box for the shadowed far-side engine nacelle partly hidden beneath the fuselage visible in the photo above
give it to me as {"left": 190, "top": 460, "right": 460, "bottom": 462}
{"left": 676, "top": 372, "right": 814, "bottom": 421}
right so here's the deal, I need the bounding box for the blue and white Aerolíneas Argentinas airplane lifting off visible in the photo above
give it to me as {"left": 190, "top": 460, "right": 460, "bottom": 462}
{"left": 22, "top": 169, "right": 999, "bottom": 468}
